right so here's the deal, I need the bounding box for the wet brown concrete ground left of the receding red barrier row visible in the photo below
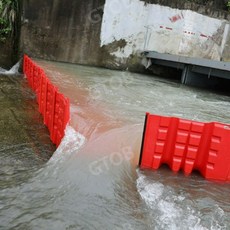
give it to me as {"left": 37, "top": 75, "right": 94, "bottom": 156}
{"left": 0, "top": 75, "right": 55, "bottom": 188}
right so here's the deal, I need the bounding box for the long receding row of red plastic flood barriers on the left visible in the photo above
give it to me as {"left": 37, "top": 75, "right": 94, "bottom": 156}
{"left": 23, "top": 55, "right": 70, "bottom": 146}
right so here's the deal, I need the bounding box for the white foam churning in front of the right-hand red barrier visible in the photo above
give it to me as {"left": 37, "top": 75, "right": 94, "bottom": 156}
{"left": 137, "top": 172, "right": 208, "bottom": 230}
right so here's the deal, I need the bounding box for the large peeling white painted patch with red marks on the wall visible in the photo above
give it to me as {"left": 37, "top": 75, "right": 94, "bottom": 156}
{"left": 101, "top": 0, "right": 229, "bottom": 60}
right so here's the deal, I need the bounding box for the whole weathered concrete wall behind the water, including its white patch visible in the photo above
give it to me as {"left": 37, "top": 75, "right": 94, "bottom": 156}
{"left": 21, "top": 0, "right": 230, "bottom": 70}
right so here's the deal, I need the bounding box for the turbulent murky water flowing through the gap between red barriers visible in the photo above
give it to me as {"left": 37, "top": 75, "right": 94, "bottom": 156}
{"left": 0, "top": 61, "right": 230, "bottom": 230}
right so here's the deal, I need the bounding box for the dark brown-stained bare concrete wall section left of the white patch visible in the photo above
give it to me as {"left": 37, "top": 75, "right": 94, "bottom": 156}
{"left": 21, "top": 0, "right": 105, "bottom": 65}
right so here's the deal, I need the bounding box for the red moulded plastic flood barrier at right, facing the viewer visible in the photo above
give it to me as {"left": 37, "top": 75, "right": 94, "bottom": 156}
{"left": 139, "top": 113, "right": 230, "bottom": 181}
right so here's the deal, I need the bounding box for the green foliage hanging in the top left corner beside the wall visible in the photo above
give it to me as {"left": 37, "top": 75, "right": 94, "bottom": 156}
{"left": 0, "top": 0, "right": 19, "bottom": 42}
